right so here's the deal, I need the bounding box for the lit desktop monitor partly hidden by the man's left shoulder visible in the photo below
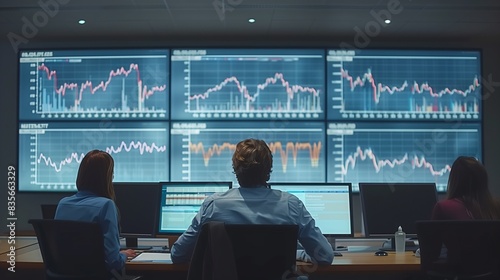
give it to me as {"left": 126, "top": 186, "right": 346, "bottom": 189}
{"left": 158, "top": 182, "right": 232, "bottom": 235}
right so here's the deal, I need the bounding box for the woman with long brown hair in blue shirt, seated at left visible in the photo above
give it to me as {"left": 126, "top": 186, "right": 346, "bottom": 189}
{"left": 54, "top": 150, "right": 136, "bottom": 272}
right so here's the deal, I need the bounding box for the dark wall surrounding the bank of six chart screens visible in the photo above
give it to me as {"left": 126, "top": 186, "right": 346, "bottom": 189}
{"left": 0, "top": 34, "right": 500, "bottom": 234}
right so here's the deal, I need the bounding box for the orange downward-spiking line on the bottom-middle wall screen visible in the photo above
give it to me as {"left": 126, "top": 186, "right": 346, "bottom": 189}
{"left": 189, "top": 142, "right": 322, "bottom": 173}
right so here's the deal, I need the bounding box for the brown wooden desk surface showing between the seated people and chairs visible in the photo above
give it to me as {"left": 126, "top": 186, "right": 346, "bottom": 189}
{"left": 0, "top": 240, "right": 420, "bottom": 275}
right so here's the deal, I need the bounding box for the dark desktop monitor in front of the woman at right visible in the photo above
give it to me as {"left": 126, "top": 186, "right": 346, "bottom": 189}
{"left": 359, "top": 183, "right": 437, "bottom": 249}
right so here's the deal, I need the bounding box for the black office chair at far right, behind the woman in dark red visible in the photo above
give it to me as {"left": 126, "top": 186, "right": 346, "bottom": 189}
{"left": 416, "top": 220, "right": 500, "bottom": 280}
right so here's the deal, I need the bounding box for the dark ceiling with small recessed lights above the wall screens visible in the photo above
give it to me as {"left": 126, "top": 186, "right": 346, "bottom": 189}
{"left": 0, "top": 0, "right": 500, "bottom": 43}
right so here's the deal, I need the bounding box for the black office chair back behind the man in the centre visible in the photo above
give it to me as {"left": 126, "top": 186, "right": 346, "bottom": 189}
{"left": 188, "top": 222, "right": 298, "bottom": 280}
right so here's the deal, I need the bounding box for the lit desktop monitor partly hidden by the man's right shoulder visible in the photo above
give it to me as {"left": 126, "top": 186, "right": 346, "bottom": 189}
{"left": 270, "top": 183, "right": 354, "bottom": 242}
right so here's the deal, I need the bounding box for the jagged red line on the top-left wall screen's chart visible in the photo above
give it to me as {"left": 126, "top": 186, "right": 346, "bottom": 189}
{"left": 38, "top": 63, "right": 167, "bottom": 106}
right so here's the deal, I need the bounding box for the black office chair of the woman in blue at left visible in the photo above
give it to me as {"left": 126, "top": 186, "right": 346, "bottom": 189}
{"left": 28, "top": 219, "right": 138, "bottom": 280}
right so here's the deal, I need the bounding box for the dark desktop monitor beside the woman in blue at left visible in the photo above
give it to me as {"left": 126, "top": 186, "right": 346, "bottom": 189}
{"left": 113, "top": 182, "right": 160, "bottom": 250}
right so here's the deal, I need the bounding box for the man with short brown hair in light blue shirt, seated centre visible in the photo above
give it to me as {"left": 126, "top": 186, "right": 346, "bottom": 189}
{"left": 170, "top": 139, "right": 333, "bottom": 265}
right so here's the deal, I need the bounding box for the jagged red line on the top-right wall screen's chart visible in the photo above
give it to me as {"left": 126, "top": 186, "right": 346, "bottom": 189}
{"left": 340, "top": 69, "right": 480, "bottom": 103}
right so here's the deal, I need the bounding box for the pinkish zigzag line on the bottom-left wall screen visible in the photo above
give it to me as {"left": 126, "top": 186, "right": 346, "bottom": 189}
{"left": 37, "top": 141, "right": 167, "bottom": 172}
